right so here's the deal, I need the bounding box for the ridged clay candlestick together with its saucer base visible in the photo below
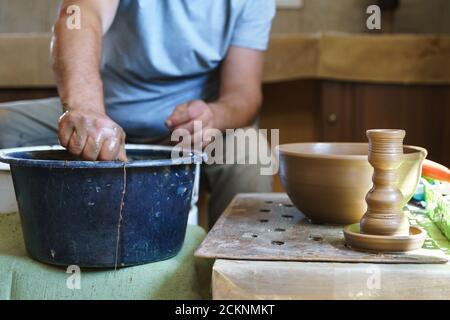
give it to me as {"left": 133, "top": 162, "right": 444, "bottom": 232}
{"left": 344, "top": 129, "right": 426, "bottom": 252}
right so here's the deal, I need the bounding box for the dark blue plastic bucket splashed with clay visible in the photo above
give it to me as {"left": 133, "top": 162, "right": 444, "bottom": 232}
{"left": 0, "top": 145, "right": 201, "bottom": 268}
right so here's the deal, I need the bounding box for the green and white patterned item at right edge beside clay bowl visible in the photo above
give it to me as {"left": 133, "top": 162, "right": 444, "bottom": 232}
{"left": 422, "top": 179, "right": 450, "bottom": 240}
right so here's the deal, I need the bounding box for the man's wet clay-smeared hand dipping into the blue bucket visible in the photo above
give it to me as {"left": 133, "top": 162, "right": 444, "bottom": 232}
{"left": 58, "top": 109, "right": 127, "bottom": 162}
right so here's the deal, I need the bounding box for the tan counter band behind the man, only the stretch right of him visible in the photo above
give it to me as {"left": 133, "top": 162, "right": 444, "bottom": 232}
{"left": 264, "top": 33, "right": 450, "bottom": 84}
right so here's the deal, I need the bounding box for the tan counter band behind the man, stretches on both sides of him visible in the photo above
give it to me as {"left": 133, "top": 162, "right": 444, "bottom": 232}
{"left": 0, "top": 33, "right": 450, "bottom": 87}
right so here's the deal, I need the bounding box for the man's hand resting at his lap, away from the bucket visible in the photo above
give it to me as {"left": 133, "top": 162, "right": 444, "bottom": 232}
{"left": 166, "top": 100, "right": 215, "bottom": 147}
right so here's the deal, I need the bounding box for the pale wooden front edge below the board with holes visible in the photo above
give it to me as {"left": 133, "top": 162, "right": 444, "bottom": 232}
{"left": 212, "top": 260, "right": 450, "bottom": 300}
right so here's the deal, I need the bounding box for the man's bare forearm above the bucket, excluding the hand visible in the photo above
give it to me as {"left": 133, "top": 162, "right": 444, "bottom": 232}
{"left": 51, "top": 1, "right": 104, "bottom": 112}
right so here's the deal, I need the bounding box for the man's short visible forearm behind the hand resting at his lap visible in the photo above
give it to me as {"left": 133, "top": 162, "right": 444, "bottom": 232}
{"left": 209, "top": 88, "right": 262, "bottom": 131}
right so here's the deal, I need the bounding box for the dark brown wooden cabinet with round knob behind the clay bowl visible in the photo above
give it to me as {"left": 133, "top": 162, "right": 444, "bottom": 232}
{"left": 320, "top": 81, "right": 450, "bottom": 166}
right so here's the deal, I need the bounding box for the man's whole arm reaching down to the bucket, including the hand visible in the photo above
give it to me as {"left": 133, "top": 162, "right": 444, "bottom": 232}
{"left": 51, "top": 0, "right": 126, "bottom": 161}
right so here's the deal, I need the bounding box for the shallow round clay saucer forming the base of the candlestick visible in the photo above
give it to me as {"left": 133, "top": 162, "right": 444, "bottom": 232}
{"left": 344, "top": 223, "right": 426, "bottom": 253}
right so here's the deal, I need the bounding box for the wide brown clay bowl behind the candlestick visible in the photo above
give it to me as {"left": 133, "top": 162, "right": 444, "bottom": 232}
{"left": 276, "top": 143, "right": 427, "bottom": 224}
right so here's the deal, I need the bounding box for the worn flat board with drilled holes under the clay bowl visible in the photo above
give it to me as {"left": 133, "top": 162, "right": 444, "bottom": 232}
{"left": 196, "top": 193, "right": 447, "bottom": 263}
